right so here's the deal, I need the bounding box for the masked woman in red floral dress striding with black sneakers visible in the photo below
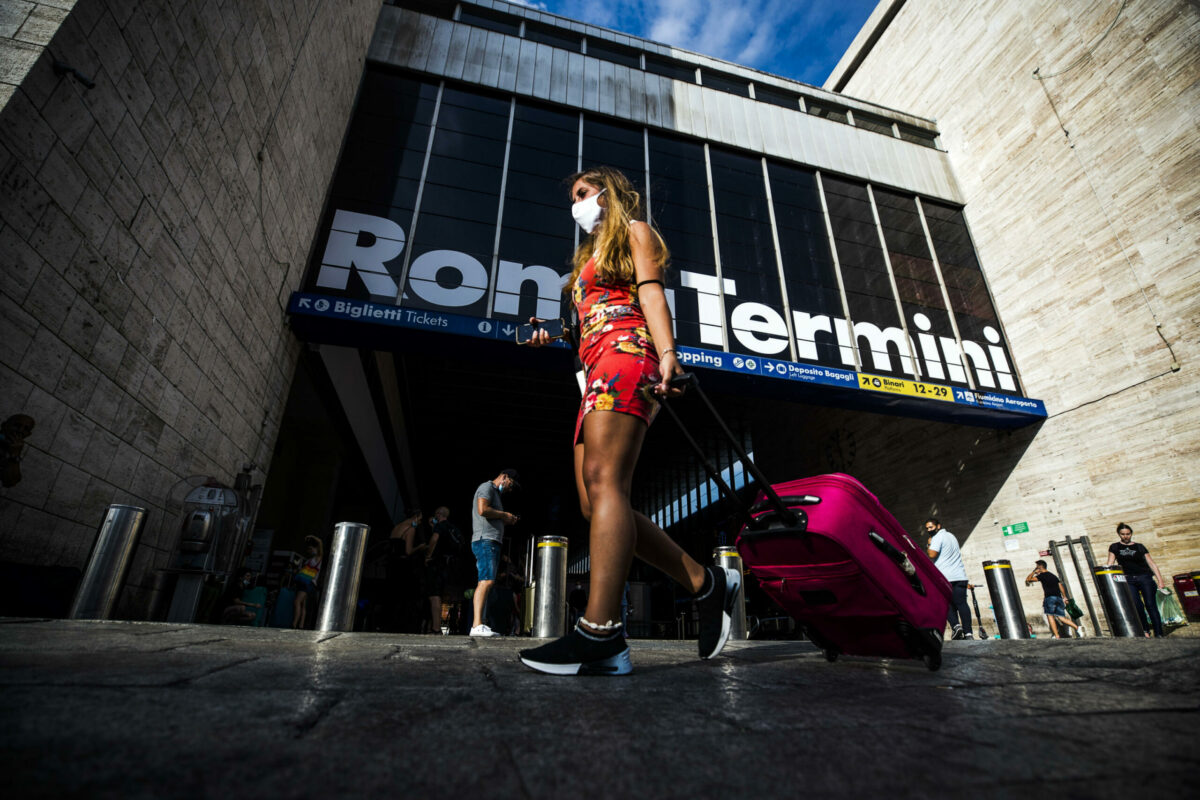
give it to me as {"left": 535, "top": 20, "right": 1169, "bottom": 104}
{"left": 521, "top": 167, "right": 742, "bottom": 675}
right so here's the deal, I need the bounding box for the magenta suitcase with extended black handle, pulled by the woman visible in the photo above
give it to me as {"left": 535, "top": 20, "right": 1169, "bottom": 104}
{"left": 664, "top": 374, "right": 950, "bottom": 669}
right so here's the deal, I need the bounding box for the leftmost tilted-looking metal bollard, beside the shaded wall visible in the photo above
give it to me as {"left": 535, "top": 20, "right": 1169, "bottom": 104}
{"left": 67, "top": 505, "right": 146, "bottom": 619}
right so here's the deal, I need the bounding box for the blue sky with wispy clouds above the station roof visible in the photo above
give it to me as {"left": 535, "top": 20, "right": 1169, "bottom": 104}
{"left": 510, "top": 0, "right": 877, "bottom": 86}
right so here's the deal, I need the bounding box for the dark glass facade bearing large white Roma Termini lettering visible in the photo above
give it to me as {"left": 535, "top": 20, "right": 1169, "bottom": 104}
{"left": 300, "top": 65, "right": 1020, "bottom": 395}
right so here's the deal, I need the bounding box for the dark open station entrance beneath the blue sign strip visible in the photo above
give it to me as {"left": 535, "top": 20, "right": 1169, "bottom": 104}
{"left": 257, "top": 319, "right": 1036, "bottom": 638}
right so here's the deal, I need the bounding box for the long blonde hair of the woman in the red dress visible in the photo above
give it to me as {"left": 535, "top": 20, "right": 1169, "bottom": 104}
{"left": 563, "top": 167, "right": 671, "bottom": 293}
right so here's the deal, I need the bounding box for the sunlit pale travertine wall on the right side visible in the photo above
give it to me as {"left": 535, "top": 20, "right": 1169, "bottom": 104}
{"left": 830, "top": 0, "right": 1200, "bottom": 616}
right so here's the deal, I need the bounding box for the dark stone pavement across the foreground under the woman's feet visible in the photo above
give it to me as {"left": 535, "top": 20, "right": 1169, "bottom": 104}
{"left": 0, "top": 619, "right": 1200, "bottom": 800}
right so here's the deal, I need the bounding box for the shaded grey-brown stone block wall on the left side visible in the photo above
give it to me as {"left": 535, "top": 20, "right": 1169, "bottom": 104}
{"left": 0, "top": 0, "right": 380, "bottom": 616}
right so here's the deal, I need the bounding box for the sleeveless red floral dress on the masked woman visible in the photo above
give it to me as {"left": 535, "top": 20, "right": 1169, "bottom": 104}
{"left": 572, "top": 258, "right": 661, "bottom": 444}
